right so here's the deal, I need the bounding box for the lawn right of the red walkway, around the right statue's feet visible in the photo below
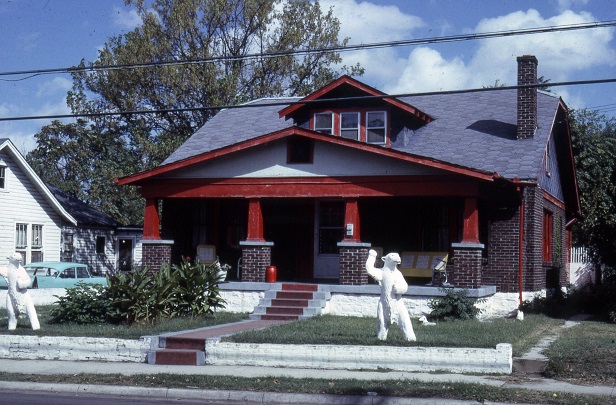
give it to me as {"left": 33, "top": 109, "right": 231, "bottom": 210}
{"left": 224, "top": 315, "right": 563, "bottom": 356}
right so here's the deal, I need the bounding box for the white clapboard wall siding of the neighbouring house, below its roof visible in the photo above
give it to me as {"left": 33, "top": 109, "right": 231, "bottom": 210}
{"left": 0, "top": 151, "right": 61, "bottom": 265}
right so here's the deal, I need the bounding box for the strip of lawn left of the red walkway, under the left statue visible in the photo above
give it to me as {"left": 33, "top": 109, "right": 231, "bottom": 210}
{"left": 0, "top": 305, "right": 248, "bottom": 339}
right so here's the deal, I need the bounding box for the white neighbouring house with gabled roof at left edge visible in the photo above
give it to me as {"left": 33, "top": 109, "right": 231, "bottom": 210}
{"left": 0, "top": 138, "right": 77, "bottom": 265}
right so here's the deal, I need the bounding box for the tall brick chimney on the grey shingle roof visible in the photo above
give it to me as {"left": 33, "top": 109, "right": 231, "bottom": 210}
{"left": 518, "top": 55, "right": 538, "bottom": 139}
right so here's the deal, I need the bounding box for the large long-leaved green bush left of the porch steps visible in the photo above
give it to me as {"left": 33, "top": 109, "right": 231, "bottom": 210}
{"left": 107, "top": 258, "right": 225, "bottom": 324}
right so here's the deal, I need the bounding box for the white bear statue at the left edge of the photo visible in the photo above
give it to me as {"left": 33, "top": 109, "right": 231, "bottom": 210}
{"left": 0, "top": 252, "right": 41, "bottom": 330}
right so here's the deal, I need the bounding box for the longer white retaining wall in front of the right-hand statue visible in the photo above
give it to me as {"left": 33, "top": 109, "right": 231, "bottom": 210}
{"left": 205, "top": 338, "right": 512, "bottom": 374}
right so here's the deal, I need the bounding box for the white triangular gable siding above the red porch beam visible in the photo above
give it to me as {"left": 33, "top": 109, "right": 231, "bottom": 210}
{"left": 166, "top": 140, "right": 439, "bottom": 178}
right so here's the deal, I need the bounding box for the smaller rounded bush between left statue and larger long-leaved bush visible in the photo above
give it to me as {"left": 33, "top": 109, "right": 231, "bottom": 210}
{"left": 50, "top": 282, "right": 112, "bottom": 324}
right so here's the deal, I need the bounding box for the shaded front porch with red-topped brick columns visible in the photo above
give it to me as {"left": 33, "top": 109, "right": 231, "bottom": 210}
{"left": 144, "top": 197, "right": 483, "bottom": 288}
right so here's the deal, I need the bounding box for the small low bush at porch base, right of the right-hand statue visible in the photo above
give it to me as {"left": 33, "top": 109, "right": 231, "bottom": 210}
{"left": 428, "top": 289, "right": 483, "bottom": 321}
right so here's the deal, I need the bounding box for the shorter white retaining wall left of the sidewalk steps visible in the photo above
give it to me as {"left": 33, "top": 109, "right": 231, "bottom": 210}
{"left": 0, "top": 335, "right": 158, "bottom": 363}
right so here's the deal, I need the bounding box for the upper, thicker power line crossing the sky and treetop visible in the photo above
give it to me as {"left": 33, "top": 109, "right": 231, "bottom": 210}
{"left": 0, "top": 20, "right": 616, "bottom": 81}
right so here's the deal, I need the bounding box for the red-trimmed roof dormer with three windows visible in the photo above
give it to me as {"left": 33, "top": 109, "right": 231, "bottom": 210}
{"left": 279, "top": 76, "right": 432, "bottom": 146}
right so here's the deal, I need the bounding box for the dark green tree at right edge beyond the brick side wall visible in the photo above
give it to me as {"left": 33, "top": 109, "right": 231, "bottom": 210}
{"left": 570, "top": 110, "right": 616, "bottom": 267}
